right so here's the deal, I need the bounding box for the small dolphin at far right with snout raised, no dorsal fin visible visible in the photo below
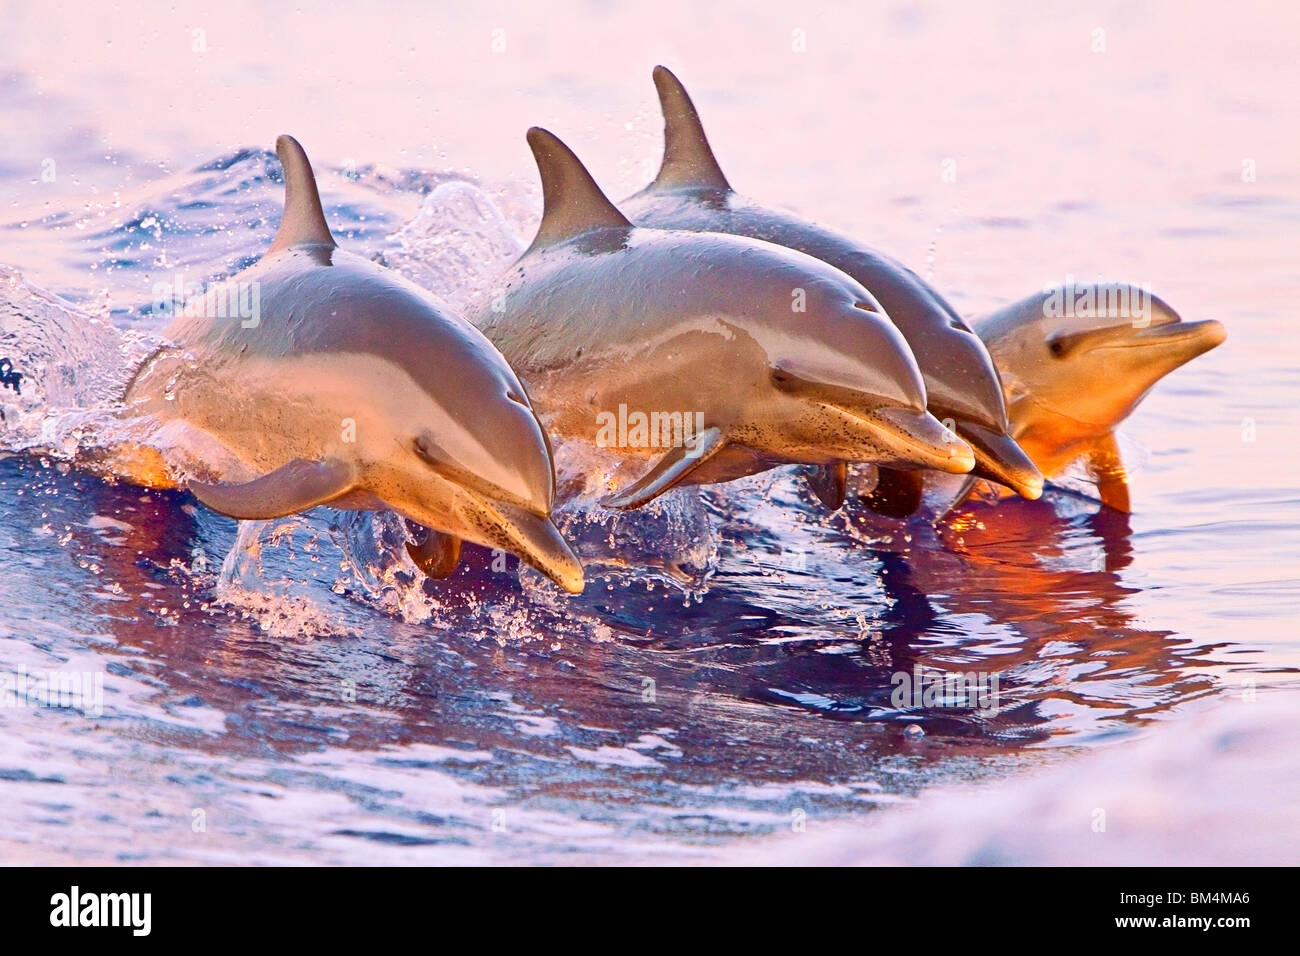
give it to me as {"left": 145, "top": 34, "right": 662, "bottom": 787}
{"left": 954, "top": 282, "right": 1227, "bottom": 512}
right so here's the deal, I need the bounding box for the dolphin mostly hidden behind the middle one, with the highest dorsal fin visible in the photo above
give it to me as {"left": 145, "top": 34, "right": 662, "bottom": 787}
{"left": 620, "top": 66, "right": 1043, "bottom": 516}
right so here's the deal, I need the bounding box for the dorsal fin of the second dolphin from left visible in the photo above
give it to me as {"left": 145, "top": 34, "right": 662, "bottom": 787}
{"left": 528, "top": 126, "right": 632, "bottom": 251}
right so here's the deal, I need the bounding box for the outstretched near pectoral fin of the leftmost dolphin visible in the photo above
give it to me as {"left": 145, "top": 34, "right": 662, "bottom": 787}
{"left": 189, "top": 458, "right": 356, "bottom": 520}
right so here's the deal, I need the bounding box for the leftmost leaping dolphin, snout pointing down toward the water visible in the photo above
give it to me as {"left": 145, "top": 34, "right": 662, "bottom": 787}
{"left": 116, "top": 137, "right": 582, "bottom": 593}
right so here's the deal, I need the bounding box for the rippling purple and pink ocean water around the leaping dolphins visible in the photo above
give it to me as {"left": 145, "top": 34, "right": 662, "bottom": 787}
{"left": 0, "top": 3, "right": 1300, "bottom": 864}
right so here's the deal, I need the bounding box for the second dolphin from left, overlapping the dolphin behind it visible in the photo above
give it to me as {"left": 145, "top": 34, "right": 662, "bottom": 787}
{"left": 469, "top": 127, "right": 975, "bottom": 509}
